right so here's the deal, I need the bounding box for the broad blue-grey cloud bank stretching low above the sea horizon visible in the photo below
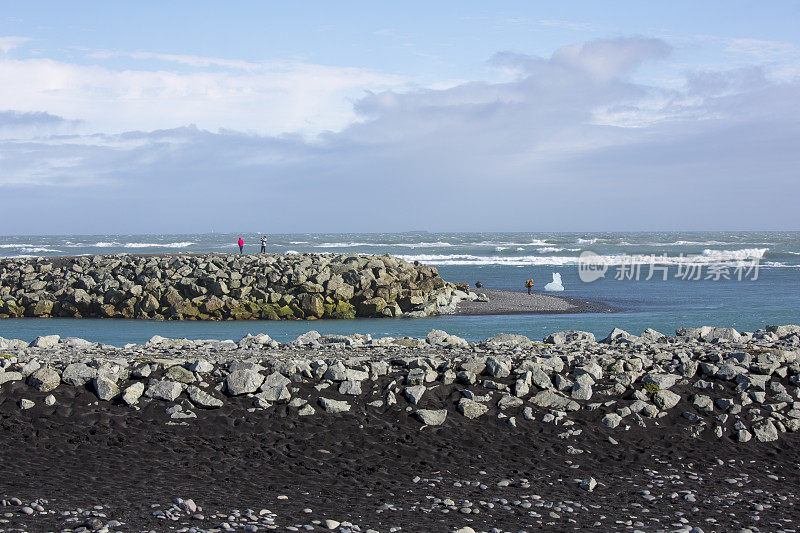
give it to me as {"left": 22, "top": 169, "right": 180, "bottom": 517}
{"left": 0, "top": 38, "right": 800, "bottom": 233}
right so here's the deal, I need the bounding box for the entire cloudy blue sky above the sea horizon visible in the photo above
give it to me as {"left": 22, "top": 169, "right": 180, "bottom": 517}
{"left": 0, "top": 0, "right": 800, "bottom": 235}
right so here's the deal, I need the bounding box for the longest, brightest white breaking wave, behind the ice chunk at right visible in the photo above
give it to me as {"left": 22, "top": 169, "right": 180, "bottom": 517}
{"left": 397, "top": 248, "right": 786, "bottom": 266}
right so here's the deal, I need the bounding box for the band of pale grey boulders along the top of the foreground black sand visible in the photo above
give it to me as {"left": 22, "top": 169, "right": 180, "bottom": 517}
{"left": 0, "top": 325, "right": 800, "bottom": 440}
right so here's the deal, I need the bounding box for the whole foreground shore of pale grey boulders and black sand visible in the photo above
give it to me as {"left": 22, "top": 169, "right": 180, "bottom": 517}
{"left": 0, "top": 326, "right": 800, "bottom": 533}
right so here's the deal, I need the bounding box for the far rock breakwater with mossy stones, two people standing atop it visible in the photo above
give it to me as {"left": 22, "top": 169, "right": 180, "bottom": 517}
{"left": 0, "top": 254, "right": 480, "bottom": 320}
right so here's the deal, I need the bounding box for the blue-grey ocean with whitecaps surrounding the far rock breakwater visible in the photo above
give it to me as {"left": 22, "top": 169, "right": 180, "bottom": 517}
{"left": 0, "top": 232, "right": 800, "bottom": 346}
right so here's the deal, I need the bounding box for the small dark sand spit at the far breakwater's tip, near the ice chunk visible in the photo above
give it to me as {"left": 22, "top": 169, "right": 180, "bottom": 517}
{"left": 456, "top": 289, "right": 616, "bottom": 315}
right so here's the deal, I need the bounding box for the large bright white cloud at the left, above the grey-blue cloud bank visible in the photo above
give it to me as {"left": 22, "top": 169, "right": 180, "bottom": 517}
{"left": 0, "top": 53, "right": 405, "bottom": 135}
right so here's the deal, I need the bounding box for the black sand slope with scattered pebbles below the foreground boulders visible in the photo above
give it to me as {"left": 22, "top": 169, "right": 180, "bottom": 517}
{"left": 0, "top": 376, "right": 800, "bottom": 531}
